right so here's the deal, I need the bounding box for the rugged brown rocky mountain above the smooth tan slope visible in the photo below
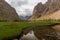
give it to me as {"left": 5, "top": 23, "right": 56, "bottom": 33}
{"left": 30, "top": 0, "right": 60, "bottom": 20}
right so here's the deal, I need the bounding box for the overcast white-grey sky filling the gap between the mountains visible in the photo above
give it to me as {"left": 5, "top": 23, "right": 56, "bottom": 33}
{"left": 5, "top": 0, "right": 47, "bottom": 16}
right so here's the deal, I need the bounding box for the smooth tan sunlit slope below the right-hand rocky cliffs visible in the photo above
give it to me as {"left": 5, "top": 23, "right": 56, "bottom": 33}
{"left": 36, "top": 10, "right": 60, "bottom": 20}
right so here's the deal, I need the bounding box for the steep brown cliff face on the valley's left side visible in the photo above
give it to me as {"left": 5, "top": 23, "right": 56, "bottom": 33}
{"left": 0, "top": 0, "right": 19, "bottom": 21}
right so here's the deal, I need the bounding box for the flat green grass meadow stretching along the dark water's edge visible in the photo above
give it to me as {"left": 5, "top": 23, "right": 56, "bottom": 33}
{"left": 0, "top": 21, "right": 58, "bottom": 40}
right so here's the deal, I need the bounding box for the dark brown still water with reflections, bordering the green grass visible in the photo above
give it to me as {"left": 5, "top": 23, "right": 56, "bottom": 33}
{"left": 2, "top": 24, "right": 60, "bottom": 40}
